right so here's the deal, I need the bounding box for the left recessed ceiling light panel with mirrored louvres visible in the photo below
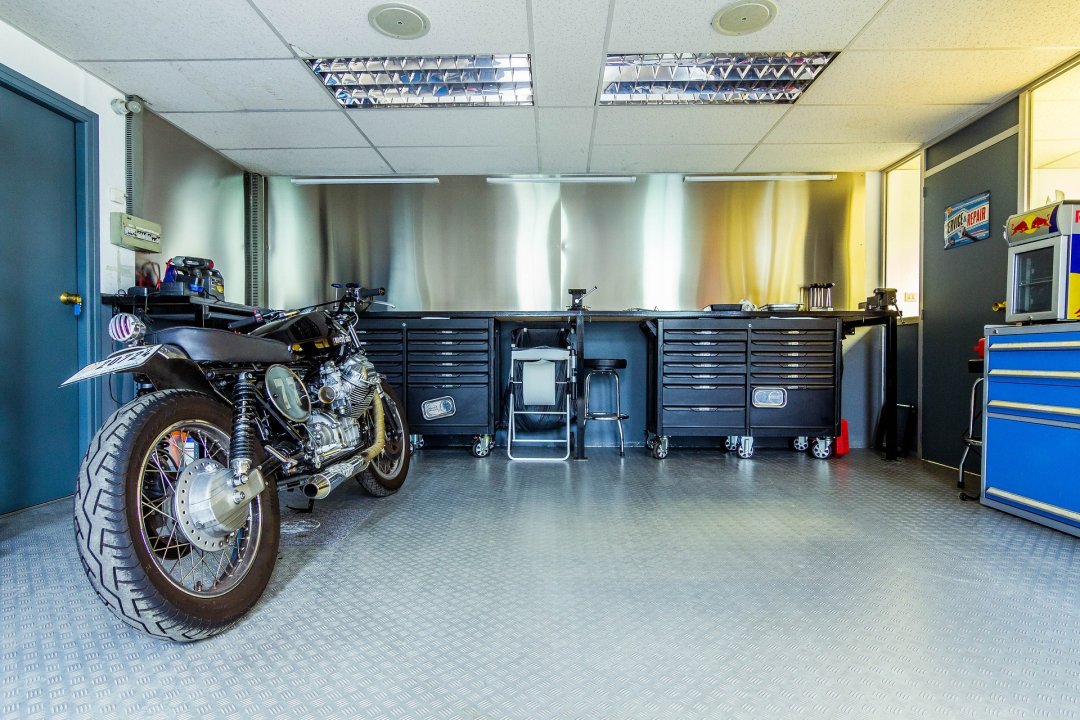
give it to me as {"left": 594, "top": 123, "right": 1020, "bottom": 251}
{"left": 305, "top": 55, "right": 532, "bottom": 108}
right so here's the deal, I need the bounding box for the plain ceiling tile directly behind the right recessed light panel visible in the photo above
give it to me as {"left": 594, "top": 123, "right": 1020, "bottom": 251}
{"left": 593, "top": 105, "right": 792, "bottom": 145}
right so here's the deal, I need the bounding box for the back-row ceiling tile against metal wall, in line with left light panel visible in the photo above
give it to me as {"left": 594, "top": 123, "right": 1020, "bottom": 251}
{"left": 382, "top": 145, "right": 539, "bottom": 175}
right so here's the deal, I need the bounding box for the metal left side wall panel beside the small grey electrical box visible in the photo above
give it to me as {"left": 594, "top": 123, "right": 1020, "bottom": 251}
{"left": 136, "top": 112, "right": 244, "bottom": 302}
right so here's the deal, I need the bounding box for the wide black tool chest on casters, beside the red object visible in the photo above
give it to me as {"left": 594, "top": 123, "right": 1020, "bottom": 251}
{"left": 647, "top": 317, "right": 842, "bottom": 458}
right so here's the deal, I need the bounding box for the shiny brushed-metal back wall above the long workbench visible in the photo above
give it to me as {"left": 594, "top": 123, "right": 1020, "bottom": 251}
{"left": 268, "top": 174, "right": 866, "bottom": 310}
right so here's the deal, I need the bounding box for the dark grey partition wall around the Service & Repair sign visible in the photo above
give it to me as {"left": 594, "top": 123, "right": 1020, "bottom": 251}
{"left": 920, "top": 100, "right": 1020, "bottom": 467}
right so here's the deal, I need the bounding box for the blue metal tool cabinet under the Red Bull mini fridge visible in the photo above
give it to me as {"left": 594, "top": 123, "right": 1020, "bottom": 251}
{"left": 983, "top": 324, "right": 1080, "bottom": 535}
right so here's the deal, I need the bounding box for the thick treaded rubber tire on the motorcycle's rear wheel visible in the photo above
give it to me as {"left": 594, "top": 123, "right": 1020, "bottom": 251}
{"left": 75, "top": 390, "right": 280, "bottom": 642}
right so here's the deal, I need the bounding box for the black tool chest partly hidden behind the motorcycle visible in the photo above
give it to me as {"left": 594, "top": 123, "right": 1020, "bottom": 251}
{"left": 356, "top": 316, "right": 497, "bottom": 456}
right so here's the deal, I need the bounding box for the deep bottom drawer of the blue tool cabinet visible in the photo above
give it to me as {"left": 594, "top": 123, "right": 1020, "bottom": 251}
{"left": 983, "top": 416, "right": 1080, "bottom": 528}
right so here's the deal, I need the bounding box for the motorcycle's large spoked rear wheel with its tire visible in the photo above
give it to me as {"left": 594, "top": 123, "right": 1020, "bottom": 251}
{"left": 75, "top": 390, "right": 280, "bottom": 642}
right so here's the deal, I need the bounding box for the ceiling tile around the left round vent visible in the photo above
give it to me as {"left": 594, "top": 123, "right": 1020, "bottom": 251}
{"left": 248, "top": 0, "right": 529, "bottom": 57}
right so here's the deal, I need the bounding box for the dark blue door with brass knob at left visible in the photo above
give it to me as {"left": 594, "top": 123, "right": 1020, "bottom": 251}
{"left": 0, "top": 85, "right": 81, "bottom": 514}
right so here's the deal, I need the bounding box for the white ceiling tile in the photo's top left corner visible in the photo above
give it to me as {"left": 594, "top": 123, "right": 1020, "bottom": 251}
{"left": 0, "top": 0, "right": 292, "bottom": 60}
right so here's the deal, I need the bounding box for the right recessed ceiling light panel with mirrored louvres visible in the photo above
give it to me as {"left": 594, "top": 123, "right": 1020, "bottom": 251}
{"left": 600, "top": 52, "right": 838, "bottom": 105}
